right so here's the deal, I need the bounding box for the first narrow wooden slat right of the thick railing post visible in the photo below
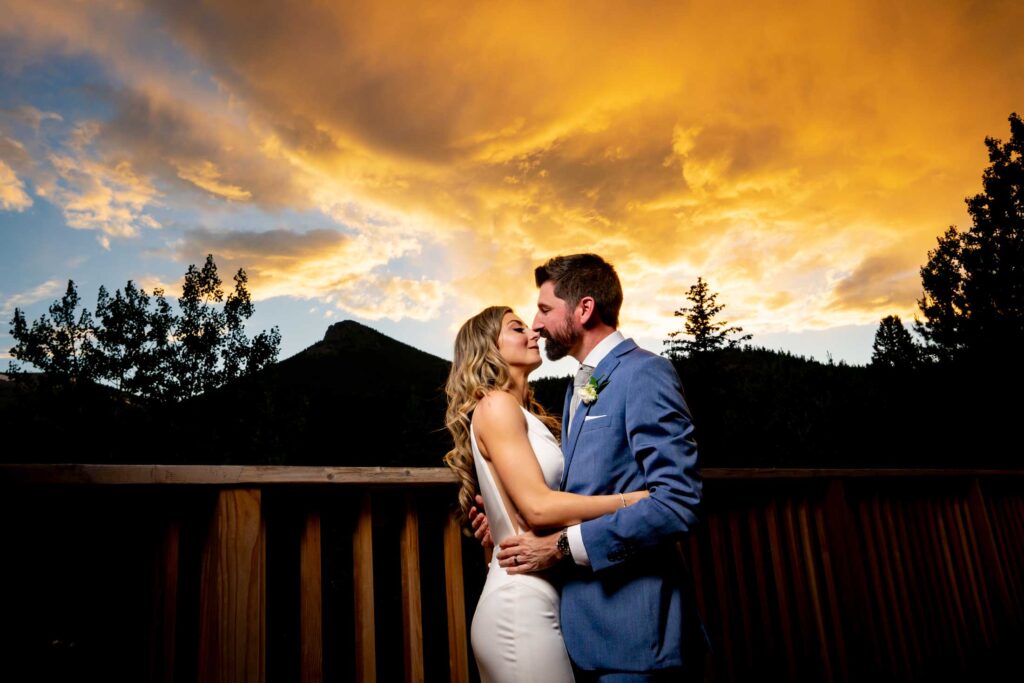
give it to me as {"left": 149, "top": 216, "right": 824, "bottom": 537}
{"left": 299, "top": 510, "right": 324, "bottom": 683}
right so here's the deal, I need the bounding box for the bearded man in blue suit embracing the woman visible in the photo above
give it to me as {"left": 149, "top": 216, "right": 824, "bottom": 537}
{"left": 483, "top": 254, "right": 709, "bottom": 683}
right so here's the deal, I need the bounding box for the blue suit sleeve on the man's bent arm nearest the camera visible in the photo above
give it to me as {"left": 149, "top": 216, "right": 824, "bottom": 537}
{"left": 581, "top": 355, "right": 702, "bottom": 571}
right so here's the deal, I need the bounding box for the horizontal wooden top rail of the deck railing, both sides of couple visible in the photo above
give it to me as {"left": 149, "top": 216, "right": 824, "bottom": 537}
{"left": 0, "top": 464, "right": 1024, "bottom": 487}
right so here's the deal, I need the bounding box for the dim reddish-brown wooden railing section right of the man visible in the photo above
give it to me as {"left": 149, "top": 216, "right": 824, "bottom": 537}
{"left": 689, "top": 469, "right": 1024, "bottom": 682}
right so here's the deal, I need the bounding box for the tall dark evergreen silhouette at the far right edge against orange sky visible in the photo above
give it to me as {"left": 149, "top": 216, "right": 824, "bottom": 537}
{"left": 916, "top": 113, "right": 1024, "bottom": 359}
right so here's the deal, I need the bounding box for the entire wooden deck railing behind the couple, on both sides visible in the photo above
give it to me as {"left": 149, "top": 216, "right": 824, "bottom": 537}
{"left": 0, "top": 465, "right": 1024, "bottom": 682}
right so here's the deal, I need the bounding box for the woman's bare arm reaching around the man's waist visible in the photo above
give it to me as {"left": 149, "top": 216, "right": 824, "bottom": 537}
{"left": 473, "top": 391, "right": 648, "bottom": 528}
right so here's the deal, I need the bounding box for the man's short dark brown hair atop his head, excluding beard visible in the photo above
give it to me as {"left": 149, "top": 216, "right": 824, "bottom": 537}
{"left": 534, "top": 254, "right": 623, "bottom": 328}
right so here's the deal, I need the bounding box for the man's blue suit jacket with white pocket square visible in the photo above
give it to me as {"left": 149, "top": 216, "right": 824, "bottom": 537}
{"left": 561, "top": 339, "right": 710, "bottom": 672}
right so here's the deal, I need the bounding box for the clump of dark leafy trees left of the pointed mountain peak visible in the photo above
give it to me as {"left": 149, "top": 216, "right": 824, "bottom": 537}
{"left": 10, "top": 254, "right": 281, "bottom": 402}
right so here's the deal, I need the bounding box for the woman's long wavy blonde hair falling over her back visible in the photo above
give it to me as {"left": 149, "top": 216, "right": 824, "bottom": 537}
{"left": 444, "top": 306, "right": 561, "bottom": 521}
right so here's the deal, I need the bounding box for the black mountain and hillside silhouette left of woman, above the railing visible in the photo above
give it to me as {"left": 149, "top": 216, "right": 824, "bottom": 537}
{"left": 0, "top": 321, "right": 451, "bottom": 467}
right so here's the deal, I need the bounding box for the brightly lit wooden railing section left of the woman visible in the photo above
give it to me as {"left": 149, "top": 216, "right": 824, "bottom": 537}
{"left": 0, "top": 465, "right": 469, "bottom": 682}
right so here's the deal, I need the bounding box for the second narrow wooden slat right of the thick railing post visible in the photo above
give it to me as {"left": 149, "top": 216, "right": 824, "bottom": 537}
{"left": 352, "top": 490, "right": 377, "bottom": 683}
